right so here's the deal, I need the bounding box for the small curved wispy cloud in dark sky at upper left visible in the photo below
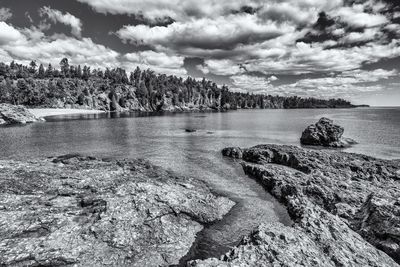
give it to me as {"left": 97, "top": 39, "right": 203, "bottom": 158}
{"left": 39, "top": 7, "right": 82, "bottom": 37}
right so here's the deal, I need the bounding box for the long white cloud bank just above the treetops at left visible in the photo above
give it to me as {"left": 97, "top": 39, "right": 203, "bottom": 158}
{"left": 0, "top": 22, "right": 187, "bottom": 76}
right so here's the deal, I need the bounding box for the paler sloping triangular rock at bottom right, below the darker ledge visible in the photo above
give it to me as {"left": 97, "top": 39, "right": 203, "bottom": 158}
{"left": 189, "top": 198, "right": 396, "bottom": 267}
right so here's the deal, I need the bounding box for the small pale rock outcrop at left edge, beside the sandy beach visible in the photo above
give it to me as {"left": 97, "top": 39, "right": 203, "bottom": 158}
{"left": 0, "top": 104, "right": 44, "bottom": 125}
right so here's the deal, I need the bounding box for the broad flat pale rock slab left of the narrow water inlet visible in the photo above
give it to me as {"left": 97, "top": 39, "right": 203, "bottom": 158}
{"left": 0, "top": 156, "right": 234, "bottom": 266}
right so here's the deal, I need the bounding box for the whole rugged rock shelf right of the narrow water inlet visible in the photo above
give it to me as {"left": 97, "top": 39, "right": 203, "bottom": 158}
{"left": 191, "top": 145, "right": 400, "bottom": 266}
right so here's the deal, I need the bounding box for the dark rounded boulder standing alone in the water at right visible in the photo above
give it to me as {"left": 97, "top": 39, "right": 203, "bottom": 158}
{"left": 300, "top": 118, "right": 356, "bottom": 148}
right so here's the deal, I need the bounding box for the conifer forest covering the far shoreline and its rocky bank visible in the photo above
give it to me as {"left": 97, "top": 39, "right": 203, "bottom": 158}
{"left": 0, "top": 58, "right": 353, "bottom": 111}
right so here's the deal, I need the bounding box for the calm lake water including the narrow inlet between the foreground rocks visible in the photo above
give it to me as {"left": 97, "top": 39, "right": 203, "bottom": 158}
{"left": 0, "top": 108, "right": 400, "bottom": 258}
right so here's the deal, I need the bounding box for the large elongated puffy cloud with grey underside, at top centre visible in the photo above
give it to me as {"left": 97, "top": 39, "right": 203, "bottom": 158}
{"left": 117, "top": 14, "right": 294, "bottom": 51}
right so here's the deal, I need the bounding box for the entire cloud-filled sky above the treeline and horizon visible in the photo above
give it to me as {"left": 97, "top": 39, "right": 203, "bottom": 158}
{"left": 0, "top": 0, "right": 400, "bottom": 106}
